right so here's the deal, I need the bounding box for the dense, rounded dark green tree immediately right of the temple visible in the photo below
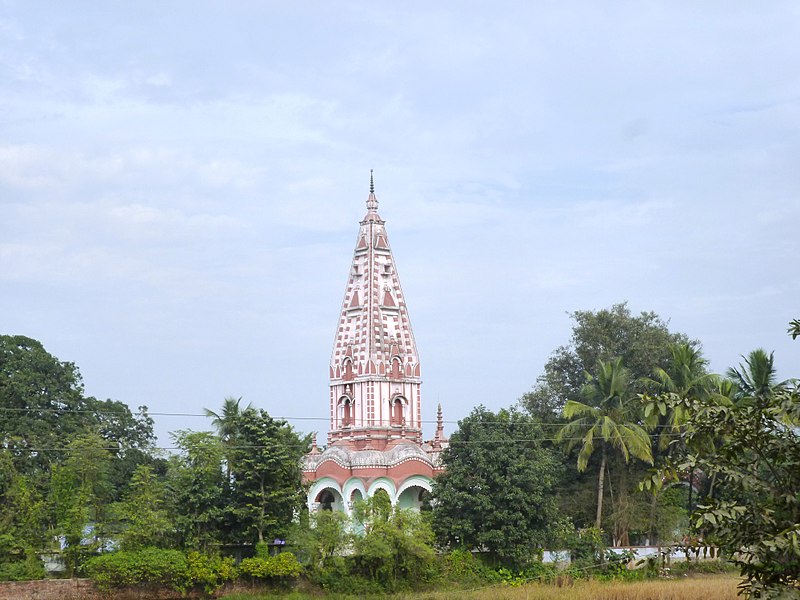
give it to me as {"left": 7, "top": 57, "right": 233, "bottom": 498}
{"left": 433, "top": 406, "right": 564, "bottom": 566}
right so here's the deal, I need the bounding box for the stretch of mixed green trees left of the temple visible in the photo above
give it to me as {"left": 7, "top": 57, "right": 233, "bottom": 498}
{"left": 0, "top": 336, "right": 309, "bottom": 579}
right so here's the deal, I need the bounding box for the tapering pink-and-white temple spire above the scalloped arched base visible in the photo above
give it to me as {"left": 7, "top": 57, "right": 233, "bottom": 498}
{"left": 328, "top": 172, "right": 422, "bottom": 450}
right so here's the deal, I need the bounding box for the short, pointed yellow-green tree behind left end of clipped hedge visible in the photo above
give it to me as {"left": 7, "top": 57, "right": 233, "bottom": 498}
{"left": 117, "top": 465, "right": 173, "bottom": 550}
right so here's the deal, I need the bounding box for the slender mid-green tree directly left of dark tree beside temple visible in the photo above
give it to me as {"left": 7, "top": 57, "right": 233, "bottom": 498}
{"left": 168, "top": 430, "right": 227, "bottom": 551}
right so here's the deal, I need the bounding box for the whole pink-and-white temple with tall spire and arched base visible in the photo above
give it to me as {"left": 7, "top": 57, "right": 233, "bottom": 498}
{"left": 304, "top": 174, "right": 447, "bottom": 514}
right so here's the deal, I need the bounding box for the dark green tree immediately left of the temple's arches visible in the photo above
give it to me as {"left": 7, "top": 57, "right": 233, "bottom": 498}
{"left": 230, "top": 409, "right": 311, "bottom": 542}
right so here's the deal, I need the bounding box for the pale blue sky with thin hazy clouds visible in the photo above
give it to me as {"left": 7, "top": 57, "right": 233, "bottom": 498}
{"left": 0, "top": 0, "right": 800, "bottom": 445}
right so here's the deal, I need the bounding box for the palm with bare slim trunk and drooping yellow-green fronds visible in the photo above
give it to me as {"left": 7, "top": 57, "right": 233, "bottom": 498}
{"left": 556, "top": 358, "right": 653, "bottom": 529}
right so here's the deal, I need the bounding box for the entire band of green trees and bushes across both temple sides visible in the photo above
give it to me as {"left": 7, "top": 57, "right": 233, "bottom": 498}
{"left": 0, "top": 304, "right": 800, "bottom": 592}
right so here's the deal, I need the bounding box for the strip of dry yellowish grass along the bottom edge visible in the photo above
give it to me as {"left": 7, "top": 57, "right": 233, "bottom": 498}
{"left": 220, "top": 575, "right": 740, "bottom": 600}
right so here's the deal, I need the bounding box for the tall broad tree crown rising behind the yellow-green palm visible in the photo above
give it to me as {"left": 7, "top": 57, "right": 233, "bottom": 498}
{"left": 520, "top": 302, "right": 689, "bottom": 422}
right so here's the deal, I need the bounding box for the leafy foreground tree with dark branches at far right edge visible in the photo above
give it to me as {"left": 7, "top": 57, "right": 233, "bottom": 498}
{"left": 658, "top": 326, "right": 800, "bottom": 598}
